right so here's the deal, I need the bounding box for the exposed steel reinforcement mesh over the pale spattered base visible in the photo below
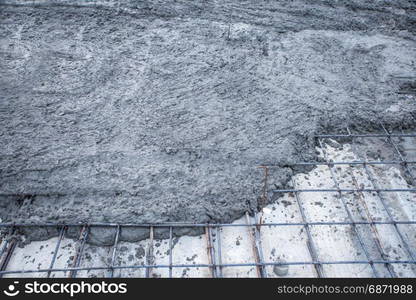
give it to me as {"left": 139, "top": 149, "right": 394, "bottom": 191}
{"left": 0, "top": 125, "right": 416, "bottom": 277}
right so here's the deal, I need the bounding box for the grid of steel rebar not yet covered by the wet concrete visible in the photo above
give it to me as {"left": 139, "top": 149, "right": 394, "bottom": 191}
{"left": 0, "top": 124, "right": 416, "bottom": 278}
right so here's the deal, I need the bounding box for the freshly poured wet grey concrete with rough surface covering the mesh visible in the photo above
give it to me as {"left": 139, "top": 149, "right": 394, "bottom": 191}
{"left": 0, "top": 0, "right": 416, "bottom": 244}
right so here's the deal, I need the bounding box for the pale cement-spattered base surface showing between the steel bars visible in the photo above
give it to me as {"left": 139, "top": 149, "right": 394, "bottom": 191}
{"left": 1, "top": 143, "right": 416, "bottom": 277}
